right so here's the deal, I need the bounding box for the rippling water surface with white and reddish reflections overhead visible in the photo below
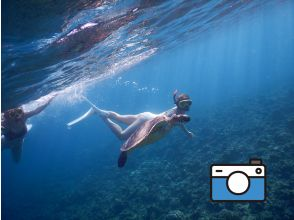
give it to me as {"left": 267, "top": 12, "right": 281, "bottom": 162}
{"left": 2, "top": 0, "right": 274, "bottom": 108}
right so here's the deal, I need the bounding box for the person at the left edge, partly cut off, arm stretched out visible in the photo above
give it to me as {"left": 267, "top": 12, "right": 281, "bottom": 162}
{"left": 1, "top": 94, "right": 56, "bottom": 162}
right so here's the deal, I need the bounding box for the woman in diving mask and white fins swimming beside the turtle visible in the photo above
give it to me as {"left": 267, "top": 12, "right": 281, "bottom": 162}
{"left": 67, "top": 90, "right": 194, "bottom": 140}
